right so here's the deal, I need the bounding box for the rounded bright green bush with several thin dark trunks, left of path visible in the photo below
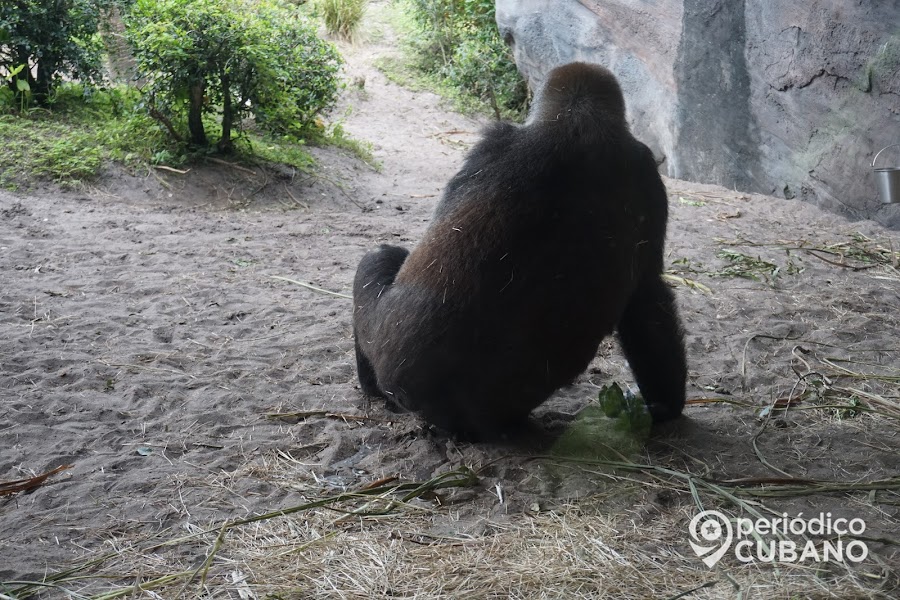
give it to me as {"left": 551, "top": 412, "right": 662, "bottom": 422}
{"left": 126, "top": 0, "right": 340, "bottom": 151}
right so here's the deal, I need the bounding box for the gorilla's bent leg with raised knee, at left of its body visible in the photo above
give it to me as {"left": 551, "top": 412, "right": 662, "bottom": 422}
{"left": 353, "top": 244, "right": 409, "bottom": 396}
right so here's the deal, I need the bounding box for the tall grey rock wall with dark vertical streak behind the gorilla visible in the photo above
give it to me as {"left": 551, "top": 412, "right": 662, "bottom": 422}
{"left": 496, "top": 0, "right": 900, "bottom": 228}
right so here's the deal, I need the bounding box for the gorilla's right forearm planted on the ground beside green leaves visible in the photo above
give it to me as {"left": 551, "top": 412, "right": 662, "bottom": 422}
{"left": 618, "top": 274, "right": 687, "bottom": 423}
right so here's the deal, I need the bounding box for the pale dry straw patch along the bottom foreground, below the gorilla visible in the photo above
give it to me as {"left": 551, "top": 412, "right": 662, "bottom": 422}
{"left": 125, "top": 506, "right": 880, "bottom": 599}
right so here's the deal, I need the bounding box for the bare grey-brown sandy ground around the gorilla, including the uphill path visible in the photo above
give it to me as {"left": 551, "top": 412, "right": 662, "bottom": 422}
{"left": 0, "top": 2, "right": 900, "bottom": 598}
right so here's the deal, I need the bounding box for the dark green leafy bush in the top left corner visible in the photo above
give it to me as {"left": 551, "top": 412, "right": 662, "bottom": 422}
{"left": 0, "top": 0, "right": 113, "bottom": 104}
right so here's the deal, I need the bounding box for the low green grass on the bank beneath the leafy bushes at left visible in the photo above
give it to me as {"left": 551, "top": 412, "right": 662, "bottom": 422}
{"left": 0, "top": 79, "right": 380, "bottom": 191}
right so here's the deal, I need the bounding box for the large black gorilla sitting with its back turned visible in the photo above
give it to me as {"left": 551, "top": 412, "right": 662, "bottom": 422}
{"left": 353, "top": 63, "right": 687, "bottom": 439}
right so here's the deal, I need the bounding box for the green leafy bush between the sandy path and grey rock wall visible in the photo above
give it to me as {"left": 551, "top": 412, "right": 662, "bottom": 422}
{"left": 407, "top": 0, "right": 528, "bottom": 118}
